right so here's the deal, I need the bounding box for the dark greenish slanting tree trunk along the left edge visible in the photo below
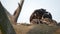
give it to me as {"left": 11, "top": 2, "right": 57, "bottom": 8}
{"left": 0, "top": 2, "right": 16, "bottom": 34}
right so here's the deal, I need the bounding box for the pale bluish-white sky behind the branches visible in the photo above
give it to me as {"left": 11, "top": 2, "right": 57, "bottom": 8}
{"left": 0, "top": 0, "right": 60, "bottom": 23}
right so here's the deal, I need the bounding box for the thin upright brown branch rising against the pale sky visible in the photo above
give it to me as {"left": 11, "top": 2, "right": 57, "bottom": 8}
{"left": 13, "top": 0, "right": 24, "bottom": 22}
